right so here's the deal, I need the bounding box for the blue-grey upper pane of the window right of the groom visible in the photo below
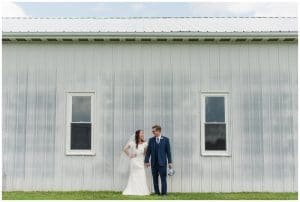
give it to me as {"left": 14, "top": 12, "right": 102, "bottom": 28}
{"left": 205, "top": 97, "right": 225, "bottom": 122}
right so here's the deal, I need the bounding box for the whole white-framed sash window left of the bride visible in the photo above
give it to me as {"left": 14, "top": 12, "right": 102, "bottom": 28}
{"left": 66, "top": 93, "right": 95, "bottom": 155}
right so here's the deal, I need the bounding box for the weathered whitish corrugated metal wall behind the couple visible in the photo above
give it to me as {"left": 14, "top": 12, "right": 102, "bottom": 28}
{"left": 2, "top": 42, "right": 298, "bottom": 192}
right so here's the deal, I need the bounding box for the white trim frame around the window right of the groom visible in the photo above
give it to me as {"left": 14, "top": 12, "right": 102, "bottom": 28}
{"left": 200, "top": 91, "right": 231, "bottom": 156}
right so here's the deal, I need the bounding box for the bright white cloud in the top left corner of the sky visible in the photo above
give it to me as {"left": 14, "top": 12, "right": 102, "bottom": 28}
{"left": 2, "top": 1, "right": 27, "bottom": 17}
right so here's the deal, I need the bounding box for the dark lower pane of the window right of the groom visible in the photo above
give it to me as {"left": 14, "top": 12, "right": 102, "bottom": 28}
{"left": 205, "top": 124, "right": 226, "bottom": 150}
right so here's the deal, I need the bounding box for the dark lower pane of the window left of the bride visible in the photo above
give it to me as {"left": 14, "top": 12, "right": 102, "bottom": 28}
{"left": 71, "top": 123, "right": 91, "bottom": 149}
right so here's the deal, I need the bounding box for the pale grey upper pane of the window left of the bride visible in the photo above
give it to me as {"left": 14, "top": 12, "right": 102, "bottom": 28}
{"left": 72, "top": 96, "right": 91, "bottom": 122}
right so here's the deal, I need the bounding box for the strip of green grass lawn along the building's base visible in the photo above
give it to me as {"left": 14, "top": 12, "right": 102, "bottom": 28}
{"left": 2, "top": 191, "right": 298, "bottom": 200}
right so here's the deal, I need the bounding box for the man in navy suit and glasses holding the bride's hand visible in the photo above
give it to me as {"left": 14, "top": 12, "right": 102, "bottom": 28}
{"left": 145, "top": 125, "right": 172, "bottom": 195}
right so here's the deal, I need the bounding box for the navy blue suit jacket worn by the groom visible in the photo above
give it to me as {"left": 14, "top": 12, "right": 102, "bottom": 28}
{"left": 145, "top": 136, "right": 172, "bottom": 166}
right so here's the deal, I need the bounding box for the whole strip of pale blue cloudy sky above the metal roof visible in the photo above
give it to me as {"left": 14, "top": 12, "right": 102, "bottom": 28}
{"left": 2, "top": 1, "right": 298, "bottom": 17}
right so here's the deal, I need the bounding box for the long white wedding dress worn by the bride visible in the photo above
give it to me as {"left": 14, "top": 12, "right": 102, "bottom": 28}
{"left": 122, "top": 141, "right": 150, "bottom": 195}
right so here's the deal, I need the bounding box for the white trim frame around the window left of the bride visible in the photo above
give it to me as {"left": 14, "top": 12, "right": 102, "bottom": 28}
{"left": 66, "top": 91, "right": 96, "bottom": 156}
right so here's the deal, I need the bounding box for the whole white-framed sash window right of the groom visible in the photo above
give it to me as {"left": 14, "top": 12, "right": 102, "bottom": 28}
{"left": 201, "top": 93, "right": 229, "bottom": 156}
